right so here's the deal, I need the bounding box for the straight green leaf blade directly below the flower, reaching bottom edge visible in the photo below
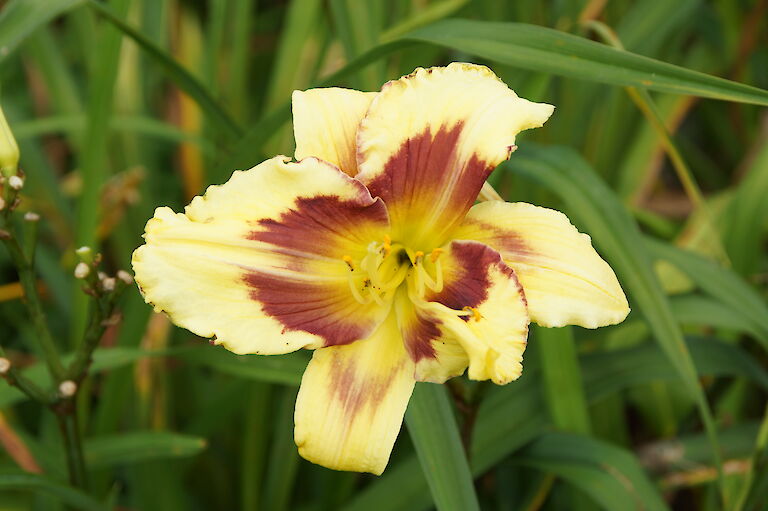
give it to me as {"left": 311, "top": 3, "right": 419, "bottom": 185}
{"left": 405, "top": 383, "right": 480, "bottom": 511}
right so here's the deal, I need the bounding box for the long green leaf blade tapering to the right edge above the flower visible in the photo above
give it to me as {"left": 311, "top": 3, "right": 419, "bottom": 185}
{"left": 403, "top": 19, "right": 768, "bottom": 105}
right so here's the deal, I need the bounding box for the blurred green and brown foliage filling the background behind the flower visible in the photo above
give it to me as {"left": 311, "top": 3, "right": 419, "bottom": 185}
{"left": 0, "top": 0, "right": 768, "bottom": 511}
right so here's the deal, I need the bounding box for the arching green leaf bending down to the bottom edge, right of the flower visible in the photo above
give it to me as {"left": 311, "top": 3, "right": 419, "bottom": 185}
{"left": 513, "top": 432, "right": 669, "bottom": 511}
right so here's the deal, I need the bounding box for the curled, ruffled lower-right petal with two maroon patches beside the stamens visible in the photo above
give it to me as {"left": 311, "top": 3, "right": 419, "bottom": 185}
{"left": 396, "top": 241, "right": 528, "bottom": 385}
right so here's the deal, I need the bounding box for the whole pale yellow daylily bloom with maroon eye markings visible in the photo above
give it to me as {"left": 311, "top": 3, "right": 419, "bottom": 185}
{"left": 133, "top": 64, "right": 629, "bottom": 474}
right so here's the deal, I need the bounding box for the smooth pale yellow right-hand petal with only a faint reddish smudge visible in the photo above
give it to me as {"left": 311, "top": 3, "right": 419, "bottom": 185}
{"left": 453, "top": 201, "right": 629, "bottom": 328}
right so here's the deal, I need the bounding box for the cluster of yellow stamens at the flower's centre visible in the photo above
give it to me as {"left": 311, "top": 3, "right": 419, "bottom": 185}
{"left": 342, "top": 236, "right": 443, "bottom": 305}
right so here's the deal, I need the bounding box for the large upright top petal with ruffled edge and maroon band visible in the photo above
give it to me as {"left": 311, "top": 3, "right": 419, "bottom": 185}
{"left": 357, "top": 63, "right": 553, "bottom": 251}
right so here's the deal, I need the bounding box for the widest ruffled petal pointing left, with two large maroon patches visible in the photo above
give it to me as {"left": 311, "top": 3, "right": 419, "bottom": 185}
{"left": 133, "top": 157, "right": 388, "bottom": 354}
